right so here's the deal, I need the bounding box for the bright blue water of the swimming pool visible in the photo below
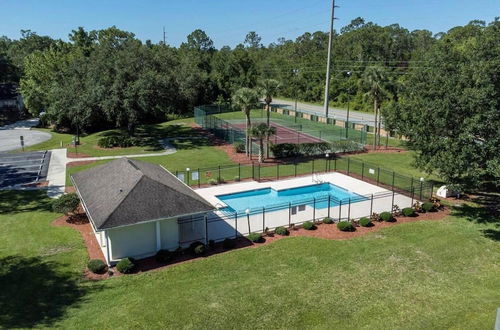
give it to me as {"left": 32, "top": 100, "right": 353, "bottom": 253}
{"left": 216, "top": 183, "right": 366, "bottom": 212}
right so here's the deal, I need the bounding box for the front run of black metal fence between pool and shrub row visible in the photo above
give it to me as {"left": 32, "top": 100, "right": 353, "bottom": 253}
{"left": 178, "top": 184, "right": 420, "bottom": 246}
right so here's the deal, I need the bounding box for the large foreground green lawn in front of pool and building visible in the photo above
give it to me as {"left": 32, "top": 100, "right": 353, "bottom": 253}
{"left": 0, "top": 191, "right": 500, "bottom": 329}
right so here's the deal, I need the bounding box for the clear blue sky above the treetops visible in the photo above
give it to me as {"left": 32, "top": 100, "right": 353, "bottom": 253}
{"left": 0, "top": 0, "right": 500, "bottom": 48}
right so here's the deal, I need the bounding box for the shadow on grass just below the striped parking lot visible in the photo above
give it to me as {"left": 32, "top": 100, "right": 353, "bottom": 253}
{"left": 0, "top": 190, "right": 52, "bottom": 214}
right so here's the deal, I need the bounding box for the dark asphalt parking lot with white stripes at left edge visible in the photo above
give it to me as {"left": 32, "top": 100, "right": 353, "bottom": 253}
{"left": 0, "top": 151, "right": 50, "bottom": 189}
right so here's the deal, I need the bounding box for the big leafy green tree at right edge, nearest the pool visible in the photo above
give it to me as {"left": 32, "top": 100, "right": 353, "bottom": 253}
{"left": 384, "top": 19, "right": 500, "bottom": 188}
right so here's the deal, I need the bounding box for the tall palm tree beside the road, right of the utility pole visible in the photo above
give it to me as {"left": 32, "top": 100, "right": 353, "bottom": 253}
{"left": 361, "top": 66, "right": 387, "bottom": 150}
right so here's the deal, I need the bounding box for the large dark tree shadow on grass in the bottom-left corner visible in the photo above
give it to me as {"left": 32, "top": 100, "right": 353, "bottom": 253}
{"left": 0, "top": 256, "right": 95, "bottom": 329}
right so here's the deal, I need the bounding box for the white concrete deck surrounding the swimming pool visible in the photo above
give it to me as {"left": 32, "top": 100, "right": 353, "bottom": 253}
{"left": 190, "top": 172, "right": 414, "bottom": 241}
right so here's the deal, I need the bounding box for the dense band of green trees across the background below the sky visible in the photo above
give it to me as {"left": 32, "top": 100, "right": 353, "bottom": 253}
{"left": 0, "top": 18, "right": 500, "bottom": 188}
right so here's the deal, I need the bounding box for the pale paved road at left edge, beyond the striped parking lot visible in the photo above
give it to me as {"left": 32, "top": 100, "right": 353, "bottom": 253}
{"left": 0, "top": 119, "right": 52, "bottom": 152}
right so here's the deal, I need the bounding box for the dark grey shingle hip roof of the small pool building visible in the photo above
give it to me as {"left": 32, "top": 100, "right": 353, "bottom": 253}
{"left": 72, "top": 158, "right": 214, "bottom": 229}
